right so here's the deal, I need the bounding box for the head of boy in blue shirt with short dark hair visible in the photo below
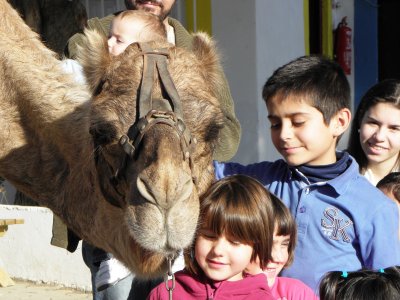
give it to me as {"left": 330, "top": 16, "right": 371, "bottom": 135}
{"left": 262, "top": 56, "right": 351, "bottom": 166}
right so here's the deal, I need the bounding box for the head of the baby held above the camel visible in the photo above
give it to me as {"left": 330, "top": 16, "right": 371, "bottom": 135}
{"left": 108, "top": 10, "right": 167, "bottom": 55}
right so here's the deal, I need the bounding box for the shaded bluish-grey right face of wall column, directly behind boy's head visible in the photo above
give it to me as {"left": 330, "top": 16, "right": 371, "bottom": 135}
{"left": 256, "top": 0, "right": 305, "bottom": 161}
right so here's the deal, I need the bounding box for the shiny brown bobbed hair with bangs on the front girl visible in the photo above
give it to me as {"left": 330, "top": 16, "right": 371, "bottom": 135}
{"left": 185, "top": 175, "right": 274, "bottom": 275}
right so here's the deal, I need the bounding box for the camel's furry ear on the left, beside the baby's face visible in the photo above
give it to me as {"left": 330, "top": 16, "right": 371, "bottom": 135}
{"left": 77, "top": 29, "right": 111, "bottom": 94}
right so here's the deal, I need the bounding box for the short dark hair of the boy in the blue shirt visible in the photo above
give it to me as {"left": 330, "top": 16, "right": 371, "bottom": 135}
{"left": 262, "top": 56, "right": 350, "bottom": 125}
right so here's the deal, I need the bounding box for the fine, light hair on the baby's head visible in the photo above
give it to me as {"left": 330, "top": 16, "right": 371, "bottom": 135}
{"left": 115, "top": 10, "right": 167, "bottom": 42}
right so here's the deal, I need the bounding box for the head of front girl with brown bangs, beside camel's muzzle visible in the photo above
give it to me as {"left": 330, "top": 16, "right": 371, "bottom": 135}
{"left": 186, "top": 175, "right": 274, "bottom": 281}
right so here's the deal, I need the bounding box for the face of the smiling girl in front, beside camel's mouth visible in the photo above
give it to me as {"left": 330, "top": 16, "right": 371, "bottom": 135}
{"left": 195, "top": 229, "right": 253, "bottom": 281}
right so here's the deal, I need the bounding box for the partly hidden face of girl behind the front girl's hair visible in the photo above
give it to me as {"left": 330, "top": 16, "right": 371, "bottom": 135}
{"left": 264, "top": 230, "right": 290, "bottom": 287}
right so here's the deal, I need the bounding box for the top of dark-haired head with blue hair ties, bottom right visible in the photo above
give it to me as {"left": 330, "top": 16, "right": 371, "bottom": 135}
{"left": 319, "top": 267, "right": 400, "bottom": 300}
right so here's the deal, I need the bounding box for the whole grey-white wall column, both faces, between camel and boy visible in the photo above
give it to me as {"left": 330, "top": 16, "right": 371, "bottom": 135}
{"left": 212, "top": 0, "right": 304, "bottom": 163}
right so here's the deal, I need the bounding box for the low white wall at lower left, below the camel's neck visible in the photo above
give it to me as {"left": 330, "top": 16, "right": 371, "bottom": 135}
{"left": 0, "top": 205, "right": 92, "bottom": 291}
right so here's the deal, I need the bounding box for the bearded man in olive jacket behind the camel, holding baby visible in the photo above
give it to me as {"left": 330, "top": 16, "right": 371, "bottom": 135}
{"left": 58, "top": 0, "right": 240, "bottom": 300}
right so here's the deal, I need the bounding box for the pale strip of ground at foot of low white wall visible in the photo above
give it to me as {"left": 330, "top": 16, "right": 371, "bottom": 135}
{"left": 0, "top": 280, "right": 92, "bottom": 300}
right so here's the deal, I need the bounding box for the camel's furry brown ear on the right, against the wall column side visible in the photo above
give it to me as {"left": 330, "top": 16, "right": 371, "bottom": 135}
{"left": 192, "top": 32, "right": 225, "bottom": 99}
